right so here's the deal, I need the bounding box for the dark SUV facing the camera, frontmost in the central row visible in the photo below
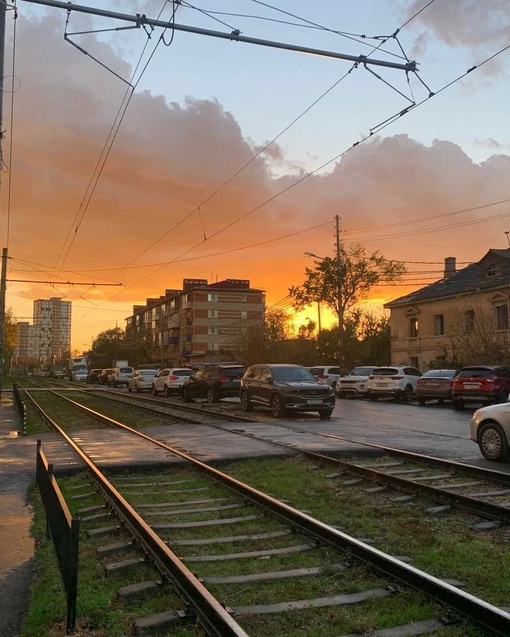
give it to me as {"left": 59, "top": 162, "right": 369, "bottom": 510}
{"left": 239, "top": 364, "right": 335, "bottom": 419}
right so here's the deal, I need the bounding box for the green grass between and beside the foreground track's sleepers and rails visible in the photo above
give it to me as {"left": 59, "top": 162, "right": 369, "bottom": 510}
{"left": 22, "top": 457, "right": 510, "bottom": 637}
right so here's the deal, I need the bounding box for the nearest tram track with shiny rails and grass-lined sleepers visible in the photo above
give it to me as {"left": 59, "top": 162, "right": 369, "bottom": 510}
{"left": 17, "top": 386, "right": 510, "bottom": 637}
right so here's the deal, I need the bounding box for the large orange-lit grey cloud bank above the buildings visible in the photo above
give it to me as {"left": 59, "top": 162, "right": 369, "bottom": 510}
{"left": 3, "top": 11, "right": 510, "bottom": 348}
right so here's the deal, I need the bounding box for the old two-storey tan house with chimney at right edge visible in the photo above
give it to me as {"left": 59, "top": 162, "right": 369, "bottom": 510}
{"left": 385, "top": 248, "right": 510, "bottom": 370}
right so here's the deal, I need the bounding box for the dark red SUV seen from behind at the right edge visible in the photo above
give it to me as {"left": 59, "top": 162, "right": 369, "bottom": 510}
{"left": 452, "top": 365, "right": 510, "bottom": 410}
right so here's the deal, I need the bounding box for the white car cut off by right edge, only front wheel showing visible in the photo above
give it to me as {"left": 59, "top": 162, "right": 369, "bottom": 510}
{"left": 470, "top": 402, "right": 510, "bottom": 461}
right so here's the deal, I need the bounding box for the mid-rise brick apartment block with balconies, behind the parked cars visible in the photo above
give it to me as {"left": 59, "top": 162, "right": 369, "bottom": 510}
{"left": 126, "top": 279, "right": 265, "bottom": 365}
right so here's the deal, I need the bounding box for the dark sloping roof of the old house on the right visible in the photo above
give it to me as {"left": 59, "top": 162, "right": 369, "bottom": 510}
{"left": 384, "top": 248, "right": 510, "bottom": 309}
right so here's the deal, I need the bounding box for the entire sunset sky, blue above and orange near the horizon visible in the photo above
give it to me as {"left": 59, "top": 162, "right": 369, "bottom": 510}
{"left": 0, "top": 0, "right": 510, "bottom": 351}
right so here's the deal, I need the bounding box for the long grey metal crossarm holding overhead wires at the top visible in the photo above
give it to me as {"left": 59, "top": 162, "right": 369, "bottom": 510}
{"left": 23, "top": 0, "right": 417, "bottom": 72}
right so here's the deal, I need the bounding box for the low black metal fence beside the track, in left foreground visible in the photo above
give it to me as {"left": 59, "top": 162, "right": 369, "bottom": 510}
{"left": 36, "top": 440, "right": 80, "bottom": 634}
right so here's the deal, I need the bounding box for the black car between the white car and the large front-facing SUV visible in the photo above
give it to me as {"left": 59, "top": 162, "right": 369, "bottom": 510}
{"left": 181, "top": 365, "right": 246, "bottom": 403}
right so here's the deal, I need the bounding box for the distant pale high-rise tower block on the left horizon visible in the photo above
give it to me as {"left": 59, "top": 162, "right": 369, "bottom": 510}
{"left": 14, "top": 297, "right": 71, "bottom": 365}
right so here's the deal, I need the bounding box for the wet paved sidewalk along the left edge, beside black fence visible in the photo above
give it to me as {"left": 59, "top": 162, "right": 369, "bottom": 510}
{"left": 0, "top": 390, "right": 36, "bottom": 637}
